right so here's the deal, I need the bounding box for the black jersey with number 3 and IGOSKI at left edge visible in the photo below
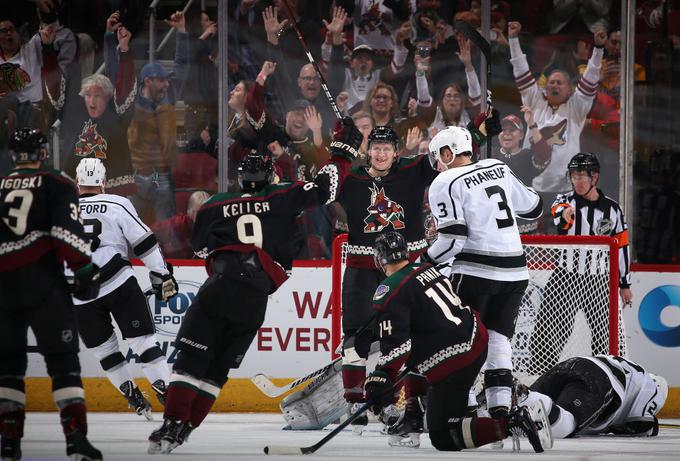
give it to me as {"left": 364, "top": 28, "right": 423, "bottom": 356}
{"left": 0, "top": 168, "right": 91, "bottom": 272}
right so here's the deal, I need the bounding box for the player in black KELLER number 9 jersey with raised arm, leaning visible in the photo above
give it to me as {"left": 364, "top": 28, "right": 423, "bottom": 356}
{"left": 149, "top": 118, "right": 362, "bottom": 453}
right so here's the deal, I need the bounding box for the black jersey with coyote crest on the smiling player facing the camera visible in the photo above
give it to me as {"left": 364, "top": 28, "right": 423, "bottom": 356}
{"left": 338, "top": 155, "right": 438, "bottom": 269}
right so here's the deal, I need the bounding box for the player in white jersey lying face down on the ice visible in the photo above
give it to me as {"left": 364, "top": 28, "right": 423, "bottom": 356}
{"left": 519, "top": 355, "right": 668, "bottom": 438}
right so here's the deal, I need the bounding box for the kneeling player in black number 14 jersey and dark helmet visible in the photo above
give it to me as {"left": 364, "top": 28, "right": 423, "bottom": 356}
{"left": 366, "top": 231, "right": 552, "bottom": 452}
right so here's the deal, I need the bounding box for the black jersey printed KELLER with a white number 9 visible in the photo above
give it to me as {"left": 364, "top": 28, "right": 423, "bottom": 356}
{"left": 191, "top": 161, "right": 348, "bottom": 287}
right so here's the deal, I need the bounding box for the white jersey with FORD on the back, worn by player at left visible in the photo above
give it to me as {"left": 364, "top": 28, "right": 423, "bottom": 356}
{"left": 67, "top": 194, "right": 168, "bottom": 304}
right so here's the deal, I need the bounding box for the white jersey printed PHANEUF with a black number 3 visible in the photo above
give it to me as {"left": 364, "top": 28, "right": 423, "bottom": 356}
{"left": 427, "top": 159, "right": 542, "bottom": 281}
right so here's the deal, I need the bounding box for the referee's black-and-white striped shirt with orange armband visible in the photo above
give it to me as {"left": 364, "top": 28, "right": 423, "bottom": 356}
{"left": 552, "top": 189, "right": 630, "bottom": 288}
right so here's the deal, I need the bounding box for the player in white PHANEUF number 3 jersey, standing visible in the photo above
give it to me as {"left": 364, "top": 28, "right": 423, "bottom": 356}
{"left": 426, "top": 127, "right": 542, "bottom": 417}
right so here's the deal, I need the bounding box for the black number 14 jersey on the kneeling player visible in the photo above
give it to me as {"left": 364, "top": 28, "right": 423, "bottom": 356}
{"left": 373, "top": 264, "right": 488, "bottom": 384}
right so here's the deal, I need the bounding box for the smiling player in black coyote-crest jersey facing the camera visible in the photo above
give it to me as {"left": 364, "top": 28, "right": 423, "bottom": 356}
{"left": 338, "top": 126, "right": 438, "bottom": 433}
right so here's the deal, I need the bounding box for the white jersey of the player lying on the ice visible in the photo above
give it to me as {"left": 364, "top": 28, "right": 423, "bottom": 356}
{"left": 580, "top": 355, "right": 665, "bottom": 434}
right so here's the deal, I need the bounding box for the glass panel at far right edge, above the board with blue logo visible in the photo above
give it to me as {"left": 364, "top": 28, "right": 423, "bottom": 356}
{"left": 632, "top": 1, "right": 680, "bottom": 264}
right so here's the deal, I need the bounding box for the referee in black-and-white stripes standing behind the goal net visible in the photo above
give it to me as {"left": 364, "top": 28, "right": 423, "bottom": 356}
{"left": 530, "top": 152, "right": 633, "bottom": 373}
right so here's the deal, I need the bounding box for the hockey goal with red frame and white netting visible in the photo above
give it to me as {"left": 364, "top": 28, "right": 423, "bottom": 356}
{"left": 331, "top": 234, "right": 626, "bottom": 384}
